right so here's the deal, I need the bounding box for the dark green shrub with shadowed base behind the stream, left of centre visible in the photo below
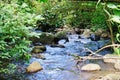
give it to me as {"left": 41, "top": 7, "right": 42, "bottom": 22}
{"left": 37, "top": 11, "right": 64, "bottom": 32}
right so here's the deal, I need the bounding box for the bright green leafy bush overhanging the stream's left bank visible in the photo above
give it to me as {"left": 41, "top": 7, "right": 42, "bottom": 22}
{"left": 0, "top": 1, "right": 41, "bottom": 73}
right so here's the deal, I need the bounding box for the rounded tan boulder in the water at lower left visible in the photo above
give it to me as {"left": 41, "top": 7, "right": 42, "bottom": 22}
{"left": 26, "top": 61, "right": 43, "bottom": 73}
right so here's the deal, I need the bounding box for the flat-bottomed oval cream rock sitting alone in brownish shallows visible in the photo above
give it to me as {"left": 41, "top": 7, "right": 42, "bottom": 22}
{"left": 81, "top": 63, "right": 101, "bottom": 71}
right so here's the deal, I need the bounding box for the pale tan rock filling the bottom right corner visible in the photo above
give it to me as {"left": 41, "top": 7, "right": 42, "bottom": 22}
{"left": 96, "top": 72, "right": 120, "bottom": 80}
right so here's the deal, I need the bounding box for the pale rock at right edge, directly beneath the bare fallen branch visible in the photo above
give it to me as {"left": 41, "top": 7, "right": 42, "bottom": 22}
{"left": 103, "top": 54, "right": 120, "bottom": 63}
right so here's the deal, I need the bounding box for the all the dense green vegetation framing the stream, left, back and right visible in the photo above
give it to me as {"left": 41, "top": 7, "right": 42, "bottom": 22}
{"left": 0, "top": 0, "right": 120, "bottom": 79}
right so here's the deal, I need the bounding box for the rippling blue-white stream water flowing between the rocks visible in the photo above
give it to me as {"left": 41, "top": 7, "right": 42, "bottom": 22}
{"left": 5, "top": 34, "right": 115, "bottom": 80}
